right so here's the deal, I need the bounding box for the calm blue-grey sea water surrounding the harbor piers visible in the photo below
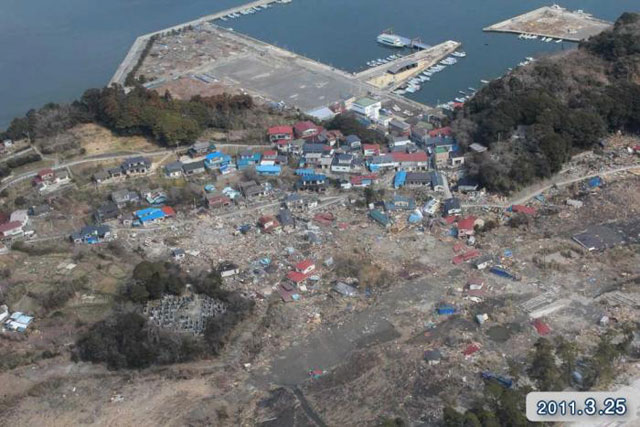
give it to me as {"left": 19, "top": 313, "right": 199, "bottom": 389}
{"left": 0, "top": 0, "right": 640, "bottom": 127}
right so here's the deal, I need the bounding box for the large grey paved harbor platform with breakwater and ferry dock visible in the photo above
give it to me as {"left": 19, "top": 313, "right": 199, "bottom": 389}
{"left": 106, "top": 0, "right": 466, "bottom": 116}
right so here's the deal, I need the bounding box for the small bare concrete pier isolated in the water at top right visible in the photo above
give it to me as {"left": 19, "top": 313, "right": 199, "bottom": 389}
{"left": 483, "top": 4, "right": 613, "bottom": 43}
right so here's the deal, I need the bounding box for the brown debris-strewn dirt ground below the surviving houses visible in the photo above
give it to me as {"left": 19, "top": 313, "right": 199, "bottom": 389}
{"left": 0, "top": 138, "right": 640, "bottom": 426}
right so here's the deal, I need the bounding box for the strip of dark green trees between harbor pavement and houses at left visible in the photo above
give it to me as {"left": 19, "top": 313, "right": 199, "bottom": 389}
{"left": 0, "top": 86, "right": 254, "bottom": 147}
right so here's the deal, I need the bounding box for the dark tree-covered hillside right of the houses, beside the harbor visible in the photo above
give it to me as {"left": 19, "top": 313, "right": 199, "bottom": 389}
{"left": 453, "top": 13, "right": 640, "bottom": 193}
